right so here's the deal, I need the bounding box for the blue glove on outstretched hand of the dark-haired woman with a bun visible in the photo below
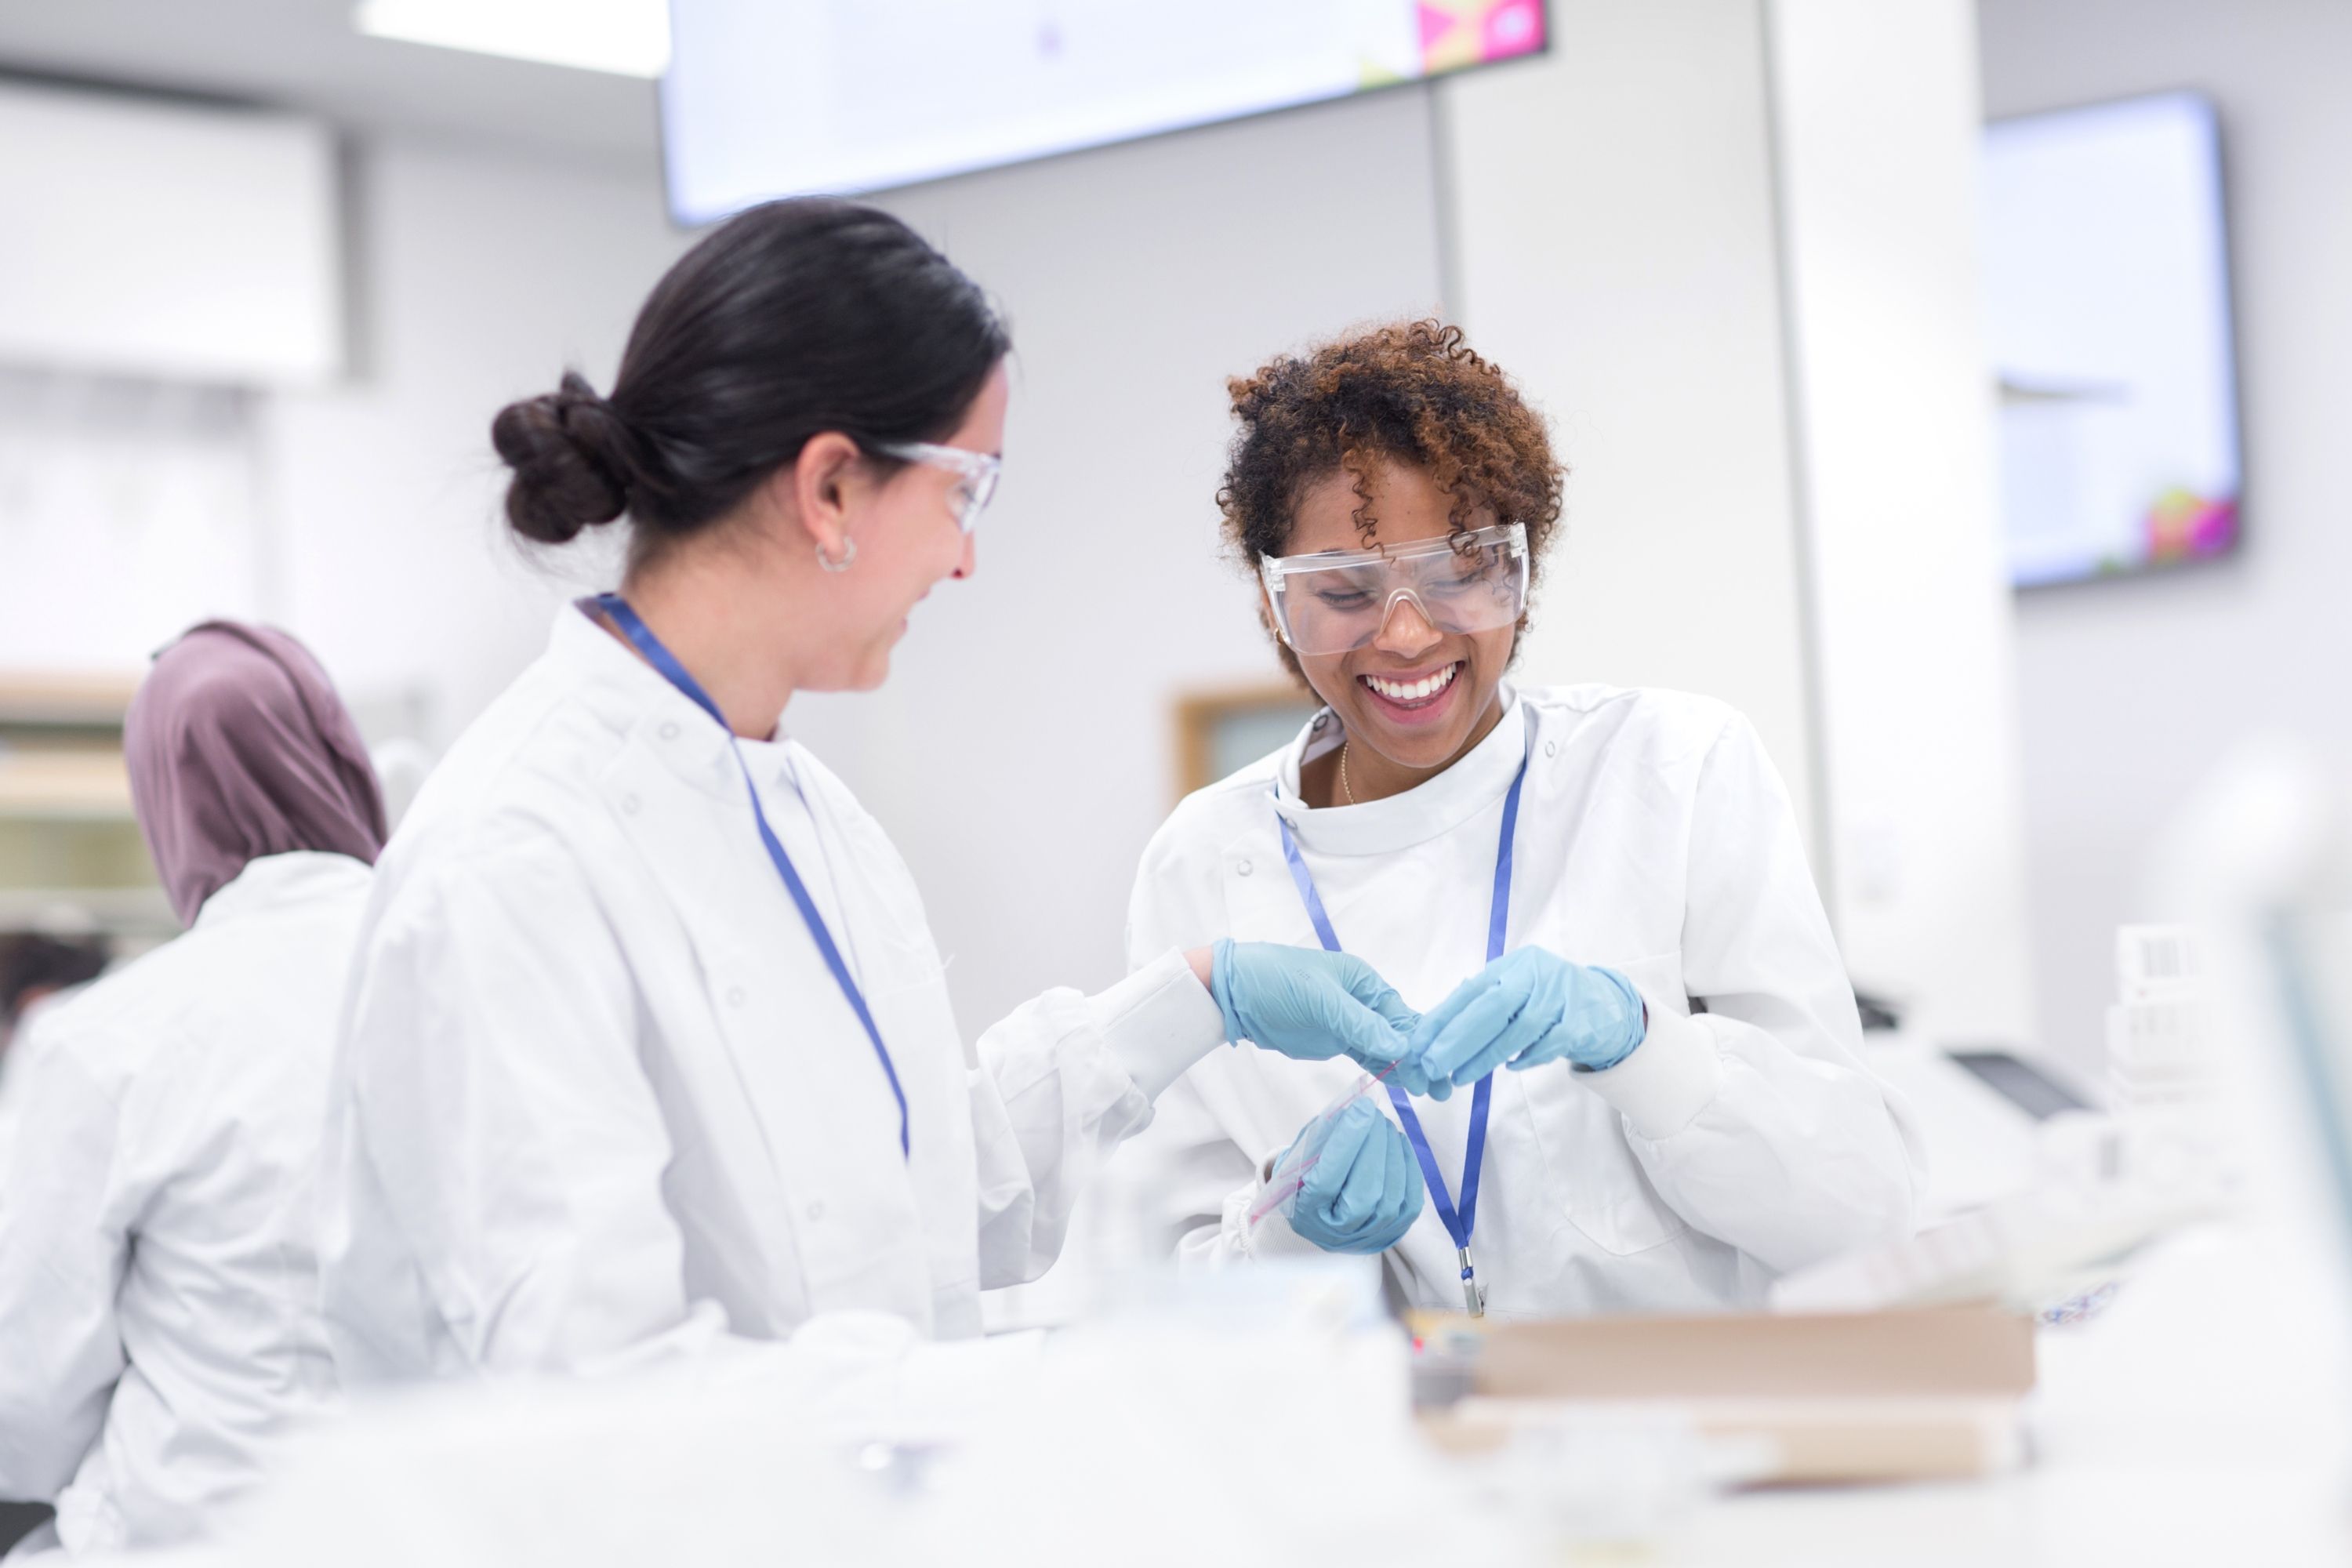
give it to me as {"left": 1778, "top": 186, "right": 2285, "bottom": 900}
{"left": 1209, "top": 938, "right": 1425, "bottom": 1093}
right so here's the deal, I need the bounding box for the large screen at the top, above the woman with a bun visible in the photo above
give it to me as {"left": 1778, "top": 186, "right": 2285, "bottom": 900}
{"left": 661, "top": 0, "right": 1548, "bottom": 223}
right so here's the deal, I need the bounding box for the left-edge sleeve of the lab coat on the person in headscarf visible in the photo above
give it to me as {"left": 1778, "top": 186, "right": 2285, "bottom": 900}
{"left": 0, "top": 1011, "right": 136, "bottom": 1502}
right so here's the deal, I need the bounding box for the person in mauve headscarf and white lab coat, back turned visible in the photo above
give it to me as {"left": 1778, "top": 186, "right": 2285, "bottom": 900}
{"left": 0, "top": 623, "right": 383, "bottom": 1552}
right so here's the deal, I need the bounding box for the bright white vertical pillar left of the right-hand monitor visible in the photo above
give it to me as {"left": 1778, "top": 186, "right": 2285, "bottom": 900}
{"left": 1766, "top": 0, "right": 2032, "bottom": 1041}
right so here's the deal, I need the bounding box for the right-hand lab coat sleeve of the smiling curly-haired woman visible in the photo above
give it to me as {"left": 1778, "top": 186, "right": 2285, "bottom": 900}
{"left": 1578, "top": 717, "right": 1926, "bottom": 1272}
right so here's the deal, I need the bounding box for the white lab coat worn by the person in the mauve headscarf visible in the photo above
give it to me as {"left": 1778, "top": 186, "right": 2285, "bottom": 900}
{"left": 0, "top": 853, "right": 369, "bottom": 1552}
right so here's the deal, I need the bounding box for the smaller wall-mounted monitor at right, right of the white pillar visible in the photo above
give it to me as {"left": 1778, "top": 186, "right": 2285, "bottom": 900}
{"left": 1985, "top": 92, "right": 2241, "bottom": 588}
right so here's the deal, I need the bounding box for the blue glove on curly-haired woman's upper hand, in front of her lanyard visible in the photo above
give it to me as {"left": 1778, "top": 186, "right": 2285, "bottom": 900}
{"left": 1414, "top": 947, "right": 1649, "bottom": 1100}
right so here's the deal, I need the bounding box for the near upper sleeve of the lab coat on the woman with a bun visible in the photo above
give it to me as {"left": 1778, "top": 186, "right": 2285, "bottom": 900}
{"left": 329, "top": 834, "right": 724, "bottom": 1370}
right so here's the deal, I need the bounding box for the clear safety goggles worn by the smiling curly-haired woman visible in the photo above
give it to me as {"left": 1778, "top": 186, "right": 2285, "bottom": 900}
{"left": 1258, "top": 522, "right": 1526, "bottom": 654}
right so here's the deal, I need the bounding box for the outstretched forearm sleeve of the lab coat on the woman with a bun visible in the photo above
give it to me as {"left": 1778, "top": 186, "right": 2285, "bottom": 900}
{"left": 969, "top": 947, "right": 1225, "bottom": 1288}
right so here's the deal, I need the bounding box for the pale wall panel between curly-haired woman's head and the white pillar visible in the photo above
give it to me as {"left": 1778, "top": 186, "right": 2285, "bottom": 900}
{"left": 1437, "top": 0, "right": 1818, "bottom": 860}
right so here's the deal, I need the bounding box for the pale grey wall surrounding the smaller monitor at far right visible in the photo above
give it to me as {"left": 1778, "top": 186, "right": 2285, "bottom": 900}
{"left": 1980, "top": 0, "right": 2352, "bottom": 1081}
